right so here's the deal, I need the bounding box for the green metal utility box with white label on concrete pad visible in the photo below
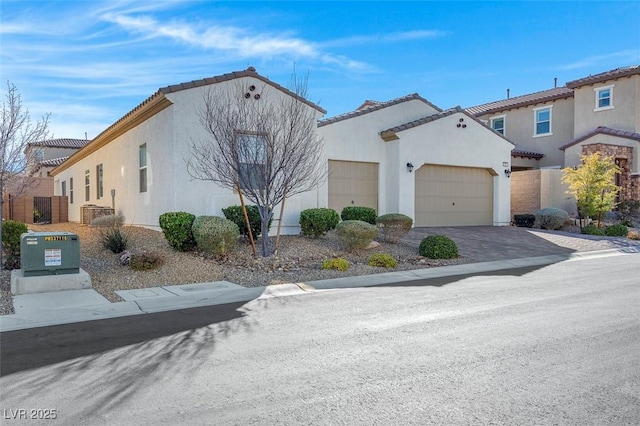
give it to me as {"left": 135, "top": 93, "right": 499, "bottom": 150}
{"left": 20, "top": 232, "right": 80, "bottom": 277}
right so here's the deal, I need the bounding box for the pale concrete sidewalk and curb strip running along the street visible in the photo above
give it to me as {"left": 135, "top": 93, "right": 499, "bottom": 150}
{"left": 0, "top": 244, "right": 640, "bottom": 332}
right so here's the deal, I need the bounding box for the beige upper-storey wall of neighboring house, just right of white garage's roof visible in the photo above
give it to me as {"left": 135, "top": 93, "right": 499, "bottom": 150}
{"left": 479, "top": 98, "right": 574, "bottom": 167}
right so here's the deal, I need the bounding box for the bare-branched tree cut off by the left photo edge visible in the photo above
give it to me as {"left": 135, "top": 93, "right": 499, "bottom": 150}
{"left": 0, "top": 82, "right": 49, "bottom": 265}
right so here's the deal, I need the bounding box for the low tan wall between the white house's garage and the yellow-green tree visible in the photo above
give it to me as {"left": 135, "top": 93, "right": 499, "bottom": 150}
{"left": 511, "top": 169, "right": 577, "bottom": 218}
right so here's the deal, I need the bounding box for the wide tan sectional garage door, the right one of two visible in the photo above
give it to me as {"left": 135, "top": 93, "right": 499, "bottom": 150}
{"left": 415, "top": 165, "right": 493, "bottom": 226}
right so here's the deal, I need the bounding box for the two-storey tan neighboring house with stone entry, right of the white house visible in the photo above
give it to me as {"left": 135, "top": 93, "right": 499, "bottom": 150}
{"left": 467, "top": 65, "right": 640, "bottom": 214}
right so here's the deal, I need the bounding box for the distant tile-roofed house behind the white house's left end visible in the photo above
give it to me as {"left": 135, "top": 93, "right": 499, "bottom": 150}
{"left": 24, "top": 138, "right": 89, "bottom": 177}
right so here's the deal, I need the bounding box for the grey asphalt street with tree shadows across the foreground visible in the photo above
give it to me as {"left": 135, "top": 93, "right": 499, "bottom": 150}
{"left": 0, "top": 254, "right": 640, "bottom": 425}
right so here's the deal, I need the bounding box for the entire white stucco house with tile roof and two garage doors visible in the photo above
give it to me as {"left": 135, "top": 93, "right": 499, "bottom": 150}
{"left": 51, "top": 67, "right": 513, "bottom": 234}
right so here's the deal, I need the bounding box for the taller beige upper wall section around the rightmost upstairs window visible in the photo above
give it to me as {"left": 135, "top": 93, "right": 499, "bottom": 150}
{"left": 574, "top": 75, "right": 640, "bottom": 139}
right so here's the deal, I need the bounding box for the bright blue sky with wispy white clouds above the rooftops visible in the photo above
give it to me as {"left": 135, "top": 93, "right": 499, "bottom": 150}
{"left": 0, "top": 0, "right": 640, "bottom": 138}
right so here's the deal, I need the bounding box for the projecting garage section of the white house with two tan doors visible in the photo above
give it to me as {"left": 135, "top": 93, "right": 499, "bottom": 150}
{"left": 318, "top": 94, "right": 513, "bottom": 226}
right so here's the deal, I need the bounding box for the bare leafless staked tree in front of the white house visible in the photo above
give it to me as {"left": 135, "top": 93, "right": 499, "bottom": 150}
{"left": 187, "top": 74, "right": 326, "bottom": 256}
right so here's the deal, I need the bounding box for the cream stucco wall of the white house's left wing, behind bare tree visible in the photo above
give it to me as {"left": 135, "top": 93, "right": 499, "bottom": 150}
{"left": 55, "top": 77, "right": 326, "bottom": 233}
